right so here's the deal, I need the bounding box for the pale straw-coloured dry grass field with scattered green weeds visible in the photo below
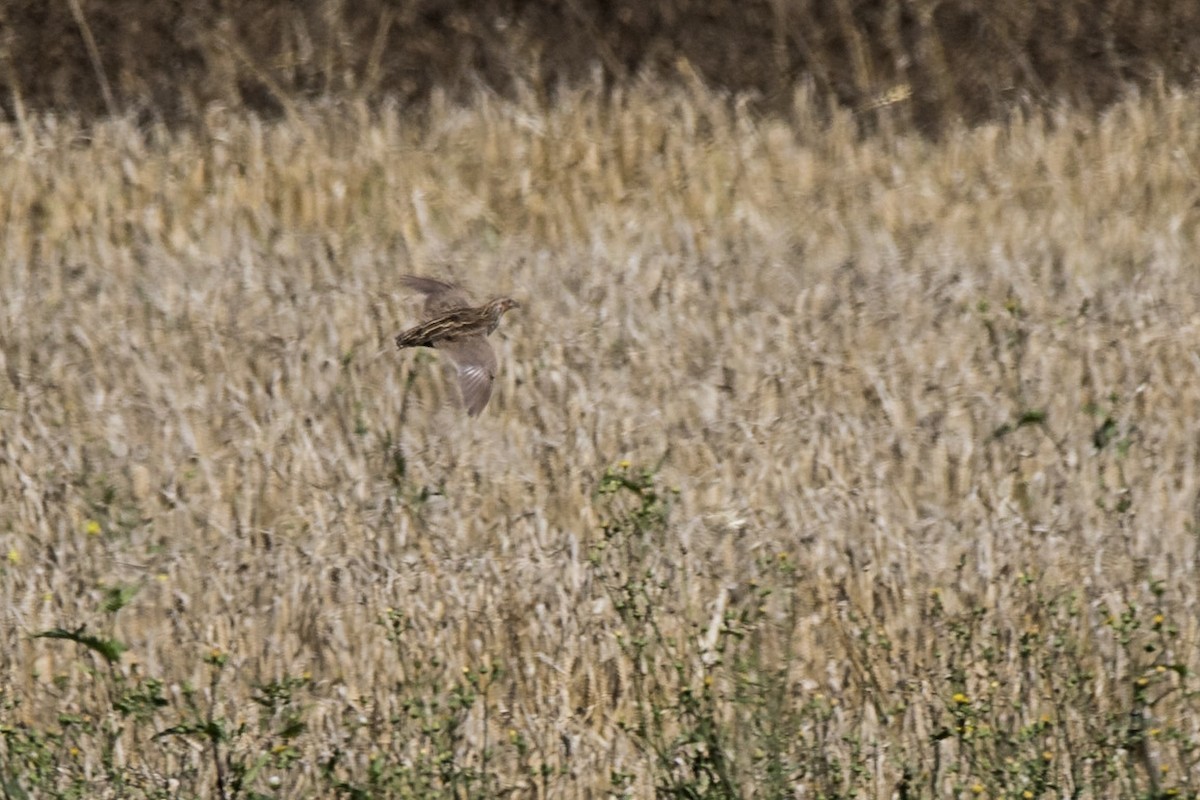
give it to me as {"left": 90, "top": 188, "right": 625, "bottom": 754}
{"left": 0, "top": 83, "right": 1200, "bottom": 799}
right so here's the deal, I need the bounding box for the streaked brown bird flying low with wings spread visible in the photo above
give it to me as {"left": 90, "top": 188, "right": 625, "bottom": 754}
{"left": 396, "top": 275, "right": 521, "bottom": 416}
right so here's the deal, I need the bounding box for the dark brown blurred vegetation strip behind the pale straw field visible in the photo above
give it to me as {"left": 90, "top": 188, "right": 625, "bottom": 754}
{"left": 7, "top": 0, "right": 1200, "bottom": 133}
